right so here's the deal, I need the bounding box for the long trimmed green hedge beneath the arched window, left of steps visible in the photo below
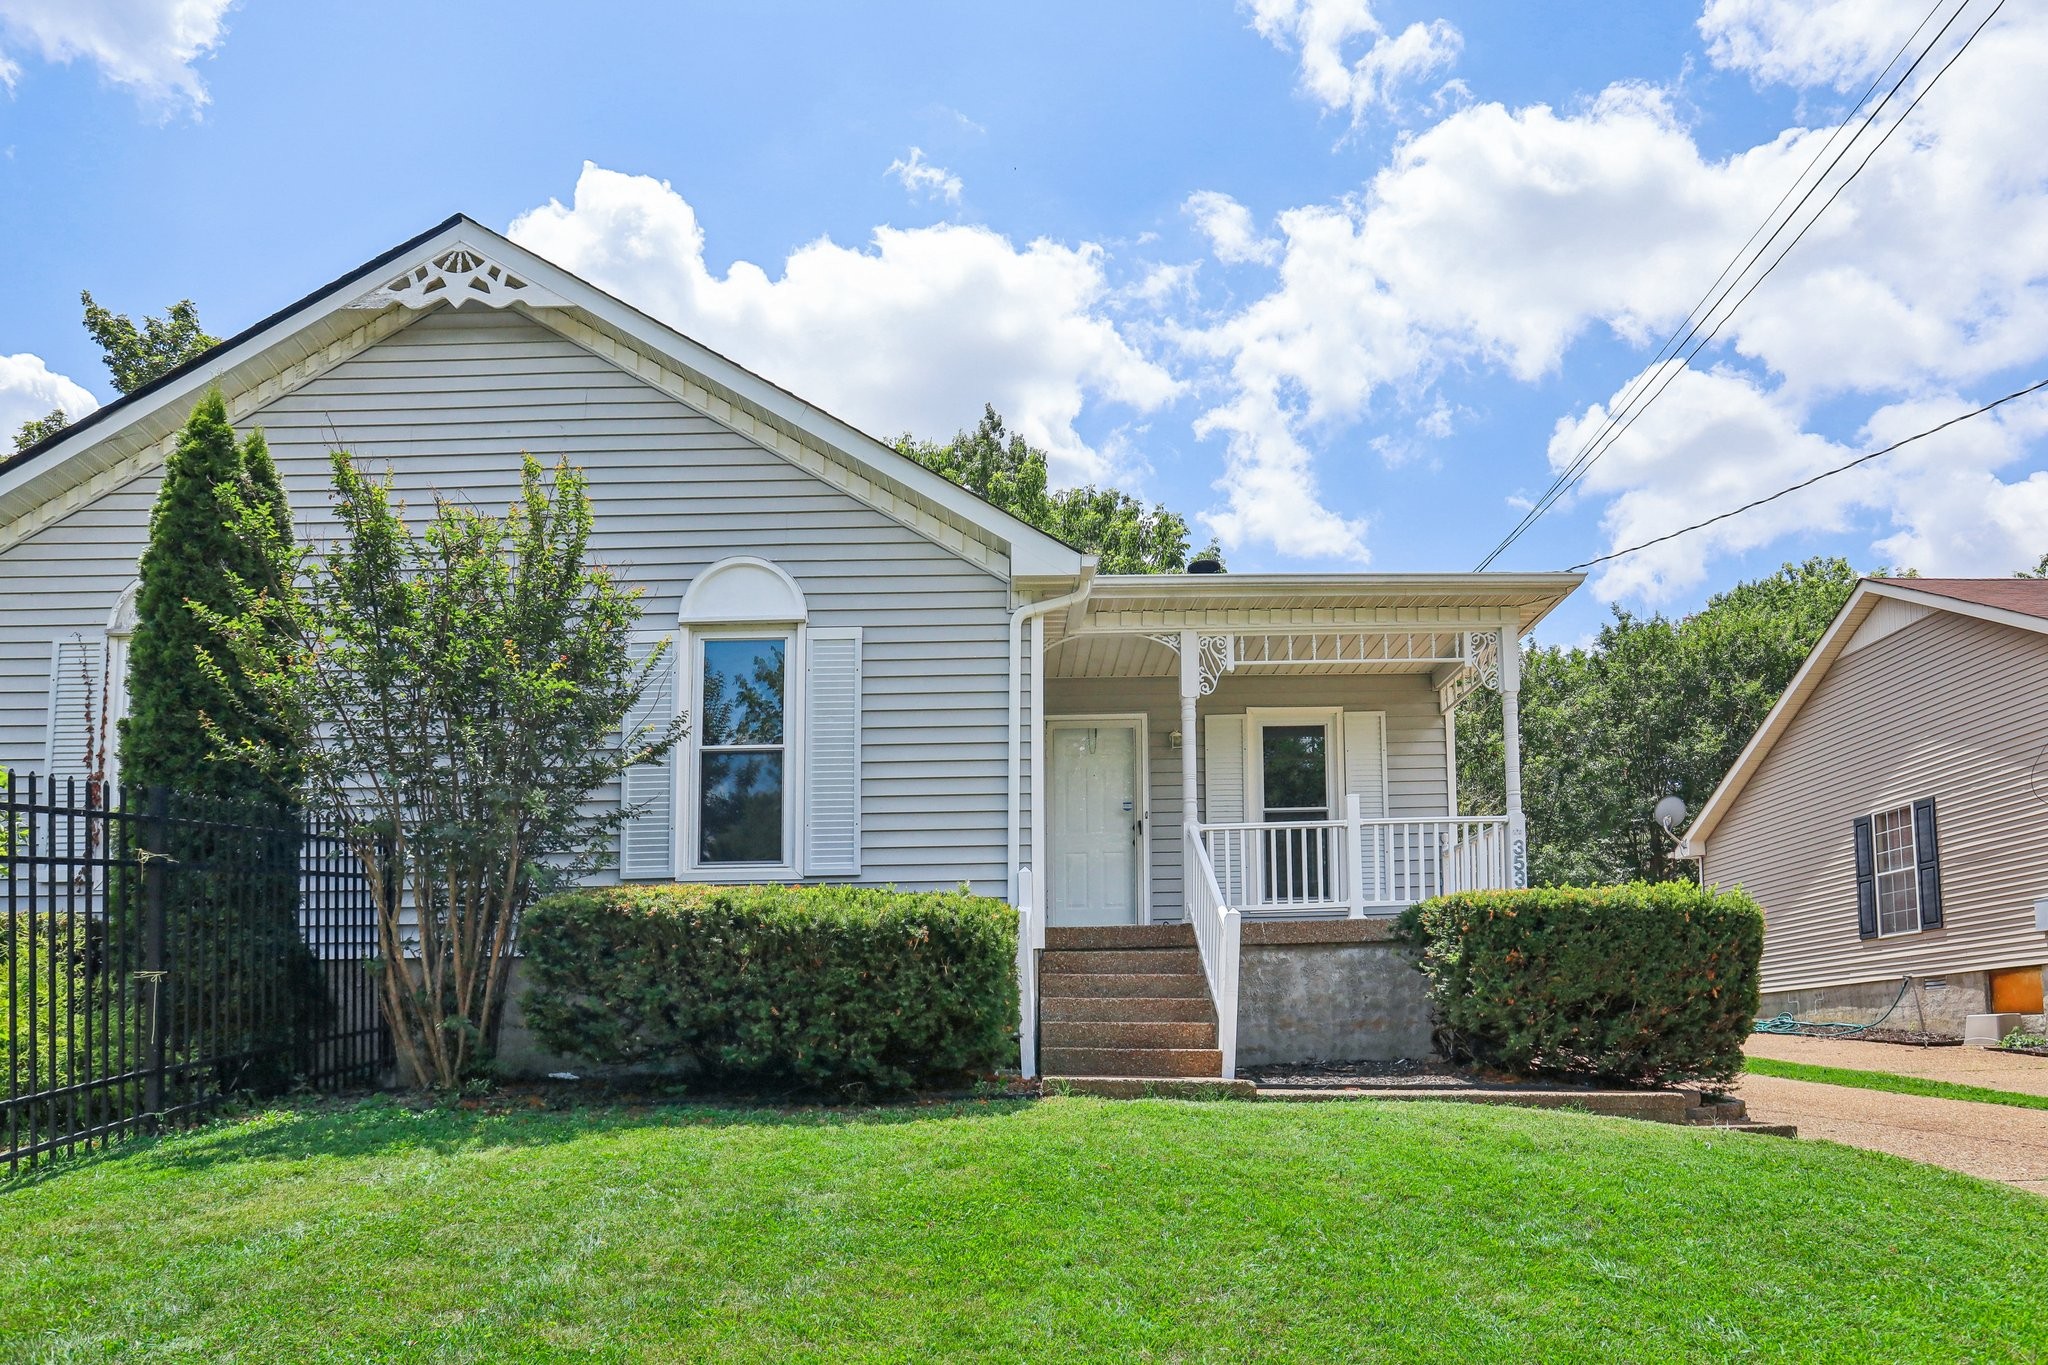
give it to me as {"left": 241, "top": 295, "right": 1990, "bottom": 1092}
{"left": 520, "top": 886, "right": 1018, "bottom": 1089}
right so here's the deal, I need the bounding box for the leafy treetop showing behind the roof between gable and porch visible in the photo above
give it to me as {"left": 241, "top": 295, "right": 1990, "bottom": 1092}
{"left": 895, "top": 403, "right": 1223, "bottom": 573}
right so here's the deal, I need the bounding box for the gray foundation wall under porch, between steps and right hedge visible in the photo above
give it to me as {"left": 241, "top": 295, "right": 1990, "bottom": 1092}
{"left": 1237, "top": 919, "right": 1436, "bottom": 1066}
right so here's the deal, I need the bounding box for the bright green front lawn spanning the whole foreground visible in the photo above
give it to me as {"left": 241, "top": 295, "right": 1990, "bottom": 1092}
{"left": 0, "top": 1099, "right": 2048, "bottom": 1361}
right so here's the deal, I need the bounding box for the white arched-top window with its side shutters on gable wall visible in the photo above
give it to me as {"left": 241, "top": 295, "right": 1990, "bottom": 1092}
{"left": 621, "top": 555, "right": 860, "bottom": 880}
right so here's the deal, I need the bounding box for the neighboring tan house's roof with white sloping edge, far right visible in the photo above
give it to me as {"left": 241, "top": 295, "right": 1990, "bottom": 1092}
{"left": 1679, "top": 579, "right": 2048, "bottom": 857}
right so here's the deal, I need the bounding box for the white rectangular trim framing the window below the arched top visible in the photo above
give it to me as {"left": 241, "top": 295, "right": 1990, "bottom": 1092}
{"left": 674, "top": 622, "right": 807, "bottom": 884}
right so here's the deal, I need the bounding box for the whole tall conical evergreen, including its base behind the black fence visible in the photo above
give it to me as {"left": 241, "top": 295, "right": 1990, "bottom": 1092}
{"left": 117, "top": 391, "right": 313, "bottom": 1091}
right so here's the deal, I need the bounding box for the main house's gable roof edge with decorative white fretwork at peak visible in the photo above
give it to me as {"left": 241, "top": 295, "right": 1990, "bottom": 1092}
{"left": 0, "top": 213, "right": 1083, "bottom": 581}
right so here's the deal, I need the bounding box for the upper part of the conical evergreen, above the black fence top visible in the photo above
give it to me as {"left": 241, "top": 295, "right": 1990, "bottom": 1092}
{"left": 119, "top": 389, "right": 297, "bottom": 806}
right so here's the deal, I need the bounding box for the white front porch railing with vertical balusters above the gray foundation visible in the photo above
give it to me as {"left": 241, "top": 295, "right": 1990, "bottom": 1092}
{"left": 1188, "top": 810, "right": 1513, "bottom": 917}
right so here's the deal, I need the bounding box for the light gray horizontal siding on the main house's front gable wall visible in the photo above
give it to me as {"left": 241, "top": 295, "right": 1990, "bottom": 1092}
{"left": 0, "top": 309, "right": 1010, "bottom": 892}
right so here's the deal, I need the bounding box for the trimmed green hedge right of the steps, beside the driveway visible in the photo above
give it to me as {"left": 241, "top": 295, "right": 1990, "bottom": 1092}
{"left": 1403, "top": 882, "right": 1763, "bottom": 1083}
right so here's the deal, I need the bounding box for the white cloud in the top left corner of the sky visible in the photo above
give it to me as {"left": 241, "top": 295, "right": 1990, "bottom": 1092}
{"left": 0, "top": 0, "right": 233, "bottom": 117}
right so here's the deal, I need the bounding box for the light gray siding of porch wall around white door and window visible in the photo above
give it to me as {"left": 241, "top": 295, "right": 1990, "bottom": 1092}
{"left": 1044, "top": 671, "right": 1450, "bottom": 919}
